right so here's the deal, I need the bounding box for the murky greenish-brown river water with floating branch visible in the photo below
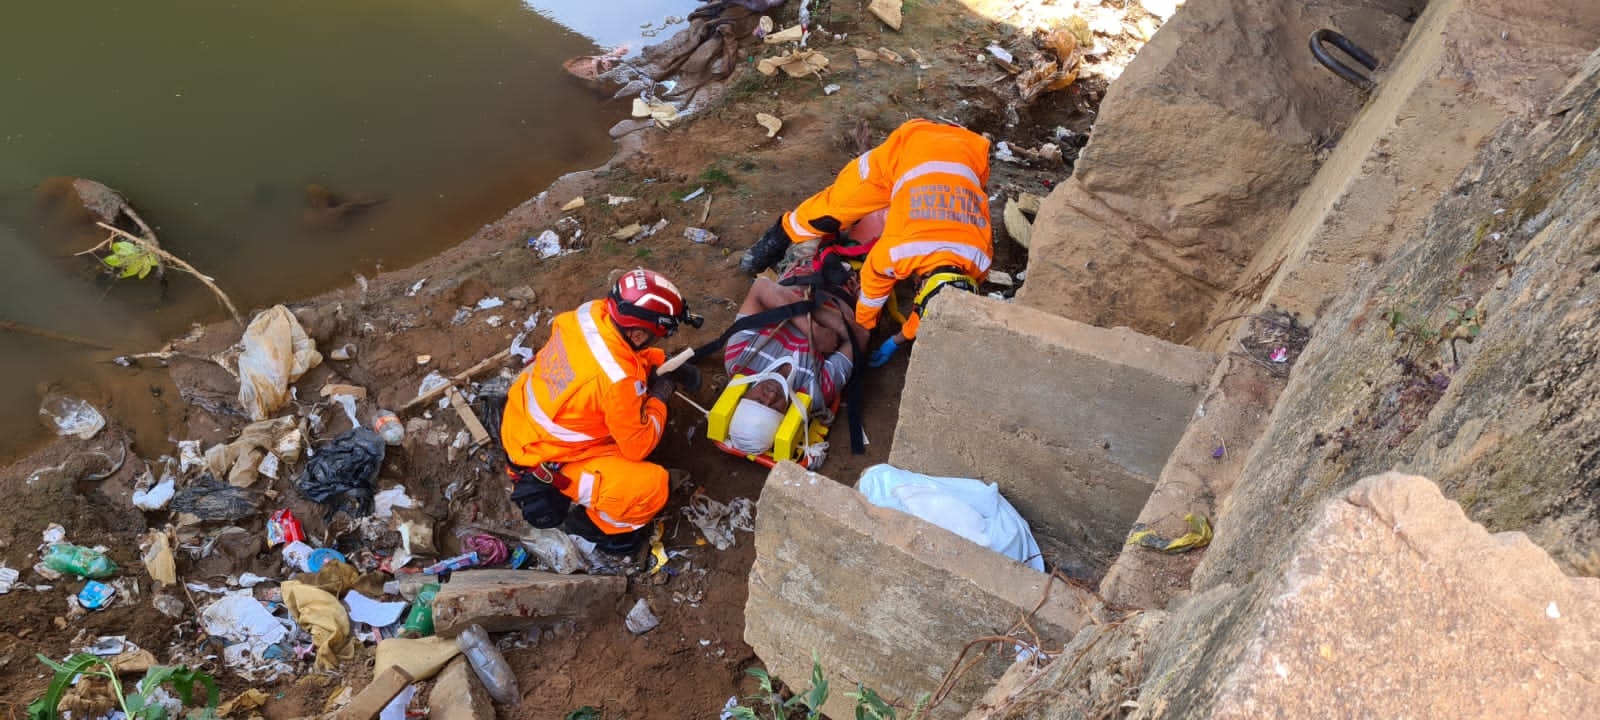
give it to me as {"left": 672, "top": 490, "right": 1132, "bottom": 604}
{"left": 0, "top": 0, "right": 696, "bottom": 454}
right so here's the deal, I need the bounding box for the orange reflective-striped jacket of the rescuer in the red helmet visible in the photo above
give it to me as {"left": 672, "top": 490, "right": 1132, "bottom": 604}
{"left": 501, "top": 301, "right": 667, "bottom": 467}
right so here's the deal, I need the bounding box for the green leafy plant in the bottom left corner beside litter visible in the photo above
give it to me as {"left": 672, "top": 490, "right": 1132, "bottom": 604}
{"left": 27, "top": 653, "right": 218, "bottom": 720}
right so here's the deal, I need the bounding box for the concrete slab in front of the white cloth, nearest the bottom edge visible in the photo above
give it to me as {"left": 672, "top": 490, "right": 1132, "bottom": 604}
{"left": 744, "top": 462, "right": 1094, "bottom": 718}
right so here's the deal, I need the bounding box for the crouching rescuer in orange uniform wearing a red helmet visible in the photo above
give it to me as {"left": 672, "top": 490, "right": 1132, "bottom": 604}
{"left": 501, "top": 269, "right": 701, "bottom": 555}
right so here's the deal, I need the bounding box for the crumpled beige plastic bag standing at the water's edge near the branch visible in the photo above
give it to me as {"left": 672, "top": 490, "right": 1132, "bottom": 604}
{"left": 238, "top": 306, "right": 322, "bottom": 421}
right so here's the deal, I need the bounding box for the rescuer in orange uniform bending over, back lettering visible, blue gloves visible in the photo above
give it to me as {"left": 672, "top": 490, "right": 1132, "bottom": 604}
{"left": 739, "top": 120, "right": 994, "bottom": 368}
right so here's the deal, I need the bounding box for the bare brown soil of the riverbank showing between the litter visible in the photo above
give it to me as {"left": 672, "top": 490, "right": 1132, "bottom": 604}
{"left": 0, "top": 2, "right": 1158, "bottom": 718}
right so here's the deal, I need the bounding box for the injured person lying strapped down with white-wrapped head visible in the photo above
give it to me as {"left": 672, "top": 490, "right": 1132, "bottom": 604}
{"left": 723, "top": 277, "right": 867, "bottom": 454}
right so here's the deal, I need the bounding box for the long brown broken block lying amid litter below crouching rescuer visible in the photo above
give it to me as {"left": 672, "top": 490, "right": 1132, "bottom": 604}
{"left": 434, "top": 570, "right": 627, "bottom": 637}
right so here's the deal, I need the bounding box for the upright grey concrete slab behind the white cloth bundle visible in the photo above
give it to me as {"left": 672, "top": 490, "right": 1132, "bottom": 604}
{"left": 890, "top": 293, "right": 1216, "bottom": 570}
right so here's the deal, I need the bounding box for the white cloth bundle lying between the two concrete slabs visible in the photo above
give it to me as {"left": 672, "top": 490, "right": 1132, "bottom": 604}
{"left": 856, "top": 464, "right": 1045, "bottom": 573}
